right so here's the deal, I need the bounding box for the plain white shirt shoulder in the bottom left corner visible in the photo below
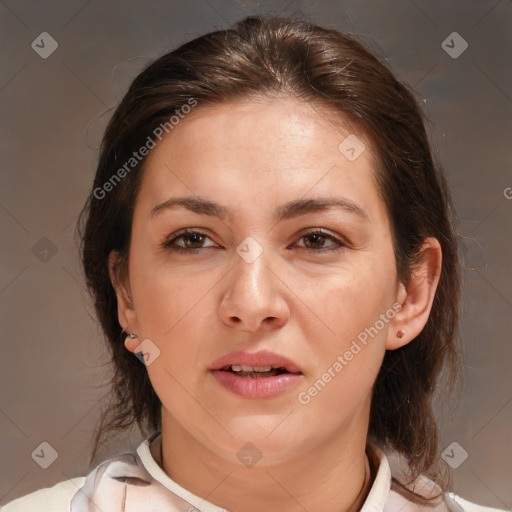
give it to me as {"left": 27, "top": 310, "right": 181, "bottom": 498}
{"left": 0, "top": 477, "right": 85, "bottom": 512}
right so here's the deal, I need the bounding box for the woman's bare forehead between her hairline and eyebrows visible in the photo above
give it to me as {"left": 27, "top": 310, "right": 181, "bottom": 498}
{"left": 139, "top": 98, "right": 384, "bottom": 224}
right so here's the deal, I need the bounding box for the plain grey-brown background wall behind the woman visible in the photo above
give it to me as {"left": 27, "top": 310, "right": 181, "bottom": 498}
{"left": 0, "top": 0, "right": 512, "bottom": 509}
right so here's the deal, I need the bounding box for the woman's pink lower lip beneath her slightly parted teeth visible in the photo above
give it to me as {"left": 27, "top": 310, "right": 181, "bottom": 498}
{"left": 212, "top": 370, "right": 302, "bottom": 398}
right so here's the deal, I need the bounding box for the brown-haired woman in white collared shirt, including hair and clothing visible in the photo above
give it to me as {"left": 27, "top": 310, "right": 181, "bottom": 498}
{"left": 4, "top": 17, "right": 504, "bottom": 512}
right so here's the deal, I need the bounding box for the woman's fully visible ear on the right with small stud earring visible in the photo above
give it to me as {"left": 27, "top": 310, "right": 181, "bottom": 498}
{"left": 386, "top": 238, "right": 442, "bottom": 350}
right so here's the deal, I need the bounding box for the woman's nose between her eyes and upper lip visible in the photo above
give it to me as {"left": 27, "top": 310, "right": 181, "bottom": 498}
{"left": 219, "top": 247, "right": 290, "bottom": 332}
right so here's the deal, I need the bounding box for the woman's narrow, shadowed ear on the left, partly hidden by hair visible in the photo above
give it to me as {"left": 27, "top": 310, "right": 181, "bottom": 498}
{"left": 108, "top": 251, "right": 140, "bottom": 352}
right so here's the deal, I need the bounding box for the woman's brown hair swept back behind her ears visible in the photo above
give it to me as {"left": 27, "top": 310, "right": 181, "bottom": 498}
{"left": 81, "top": 16, "right": 460, "bottom": 500}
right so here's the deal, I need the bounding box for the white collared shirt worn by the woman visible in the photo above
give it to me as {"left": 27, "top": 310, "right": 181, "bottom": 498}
{"left": 0, "top": 433, "right": 504, "bottom": 512}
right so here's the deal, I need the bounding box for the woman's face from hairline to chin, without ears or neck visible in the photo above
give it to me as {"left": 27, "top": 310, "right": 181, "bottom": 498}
{"left": 116, "top": 99, "right": 408, "bottom": 463}
